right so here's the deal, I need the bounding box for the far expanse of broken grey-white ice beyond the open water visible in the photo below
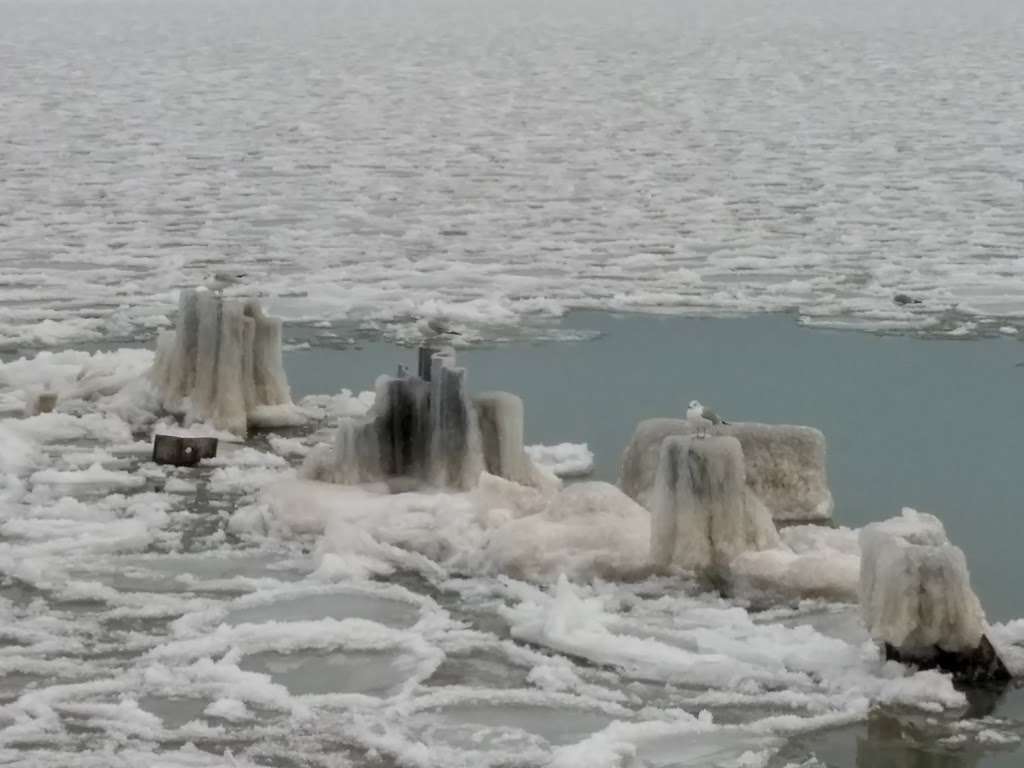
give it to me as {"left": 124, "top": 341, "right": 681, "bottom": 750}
{"left": 0, "top": 0, "right": 1024, "bottom": 346}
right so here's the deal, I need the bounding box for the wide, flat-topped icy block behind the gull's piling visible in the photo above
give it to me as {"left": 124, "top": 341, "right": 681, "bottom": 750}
{"left": 620, "top": 419, "right": 834, "bottom": 522}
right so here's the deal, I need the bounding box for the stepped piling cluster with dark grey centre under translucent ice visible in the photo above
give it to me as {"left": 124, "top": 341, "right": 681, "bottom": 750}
{"left": 302, "top": 347, "right": 550, "bottom": 490}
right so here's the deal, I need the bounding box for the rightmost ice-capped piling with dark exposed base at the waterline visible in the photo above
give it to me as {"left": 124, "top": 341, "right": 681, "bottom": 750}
{"left": 860, "top": 509, "right": 1010, "bottom": 681}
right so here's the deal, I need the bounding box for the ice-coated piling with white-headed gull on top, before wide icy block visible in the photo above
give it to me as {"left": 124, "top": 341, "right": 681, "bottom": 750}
{"left": 650, "top": 436, "right": 779, "bottom": 583}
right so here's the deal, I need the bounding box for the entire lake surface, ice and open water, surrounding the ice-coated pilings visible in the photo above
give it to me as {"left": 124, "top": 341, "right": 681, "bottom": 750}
{"left": 0, "top": 0, "right": 1024, "bottom": 768}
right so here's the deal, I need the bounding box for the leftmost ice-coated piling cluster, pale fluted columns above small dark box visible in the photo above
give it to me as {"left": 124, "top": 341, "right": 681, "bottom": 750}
{"left": 152, "top": 288, "right": 297, "bottom": 436}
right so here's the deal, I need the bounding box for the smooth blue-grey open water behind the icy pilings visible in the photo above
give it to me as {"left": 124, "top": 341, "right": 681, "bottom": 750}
{"left": 286, "top": 312, "right": 1024, "bottom": 621}
